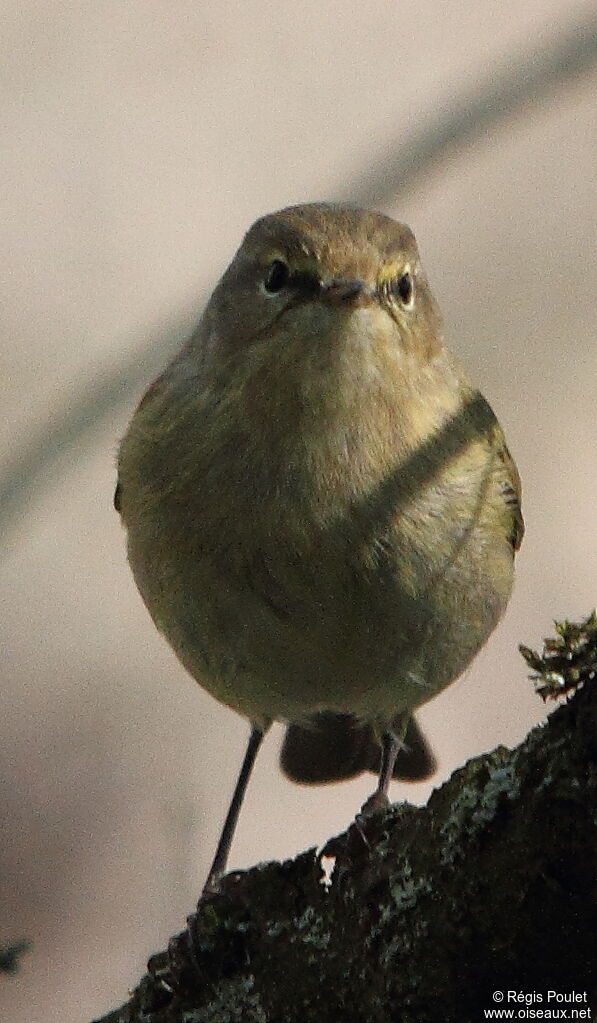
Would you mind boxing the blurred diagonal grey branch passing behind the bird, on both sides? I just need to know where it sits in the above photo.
[0,16,597,548]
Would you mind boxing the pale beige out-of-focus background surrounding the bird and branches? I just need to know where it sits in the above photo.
[0,0,597,1023]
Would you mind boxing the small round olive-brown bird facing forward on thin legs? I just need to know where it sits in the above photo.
[114,204,523,890]
